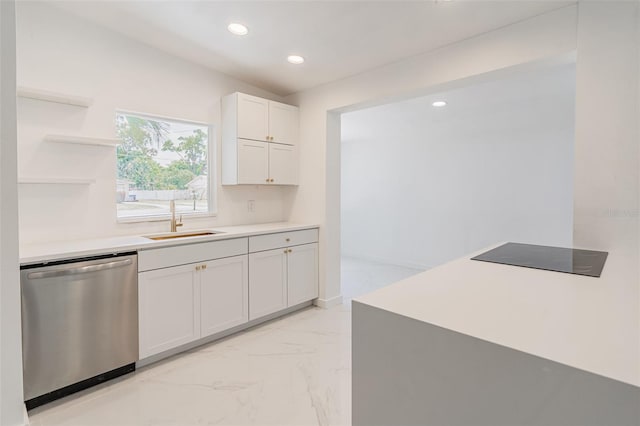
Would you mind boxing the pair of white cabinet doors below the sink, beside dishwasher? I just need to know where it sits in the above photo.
[138,255,249,359]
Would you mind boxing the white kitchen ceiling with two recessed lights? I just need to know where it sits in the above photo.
[48,0,575,96]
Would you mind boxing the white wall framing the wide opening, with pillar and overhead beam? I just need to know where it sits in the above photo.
[288,6,577,306]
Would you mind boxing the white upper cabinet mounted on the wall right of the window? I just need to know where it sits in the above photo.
[222,93,299,185]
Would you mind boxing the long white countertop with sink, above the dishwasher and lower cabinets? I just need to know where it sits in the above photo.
[20,222,318,265]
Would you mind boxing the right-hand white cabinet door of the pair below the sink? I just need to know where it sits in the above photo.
[200,255,249,337]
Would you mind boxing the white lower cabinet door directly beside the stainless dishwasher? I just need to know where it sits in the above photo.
[138,265,200,359]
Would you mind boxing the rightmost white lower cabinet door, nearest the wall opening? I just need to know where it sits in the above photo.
[287,243,318,306]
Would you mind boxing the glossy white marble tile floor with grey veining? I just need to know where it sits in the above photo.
[29,259,418,426]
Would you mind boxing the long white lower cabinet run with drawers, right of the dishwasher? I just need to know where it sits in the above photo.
[138,228,318,362]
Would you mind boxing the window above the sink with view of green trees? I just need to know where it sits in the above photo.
[116,113,213,221]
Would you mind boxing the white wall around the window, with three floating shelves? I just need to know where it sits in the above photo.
[17,2,293,243]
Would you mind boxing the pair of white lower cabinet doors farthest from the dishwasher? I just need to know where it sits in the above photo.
[249,243,318,320]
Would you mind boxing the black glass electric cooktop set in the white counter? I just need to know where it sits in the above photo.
[471,243,608,277]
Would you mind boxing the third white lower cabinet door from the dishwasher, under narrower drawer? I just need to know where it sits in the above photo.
[249,249,287,320]
